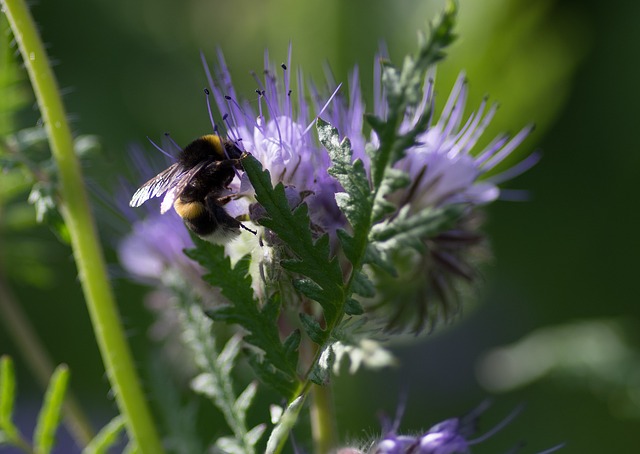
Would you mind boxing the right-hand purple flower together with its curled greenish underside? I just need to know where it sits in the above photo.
[318,58,539,332]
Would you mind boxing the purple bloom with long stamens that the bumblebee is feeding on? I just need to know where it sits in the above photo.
[205,48,345,238]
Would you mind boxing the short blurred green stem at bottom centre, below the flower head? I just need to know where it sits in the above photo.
[310,384,337,454]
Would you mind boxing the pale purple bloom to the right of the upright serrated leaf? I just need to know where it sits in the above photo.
[396,74,538,210]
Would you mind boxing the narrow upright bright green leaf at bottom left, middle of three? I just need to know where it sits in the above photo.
[33,364,69,454]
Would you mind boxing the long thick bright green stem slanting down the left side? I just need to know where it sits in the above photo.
[2,0,163,454]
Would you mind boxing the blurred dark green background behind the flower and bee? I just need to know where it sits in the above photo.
[0,0,640,453]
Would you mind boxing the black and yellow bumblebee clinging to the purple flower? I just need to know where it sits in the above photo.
[129,134,256,243]
